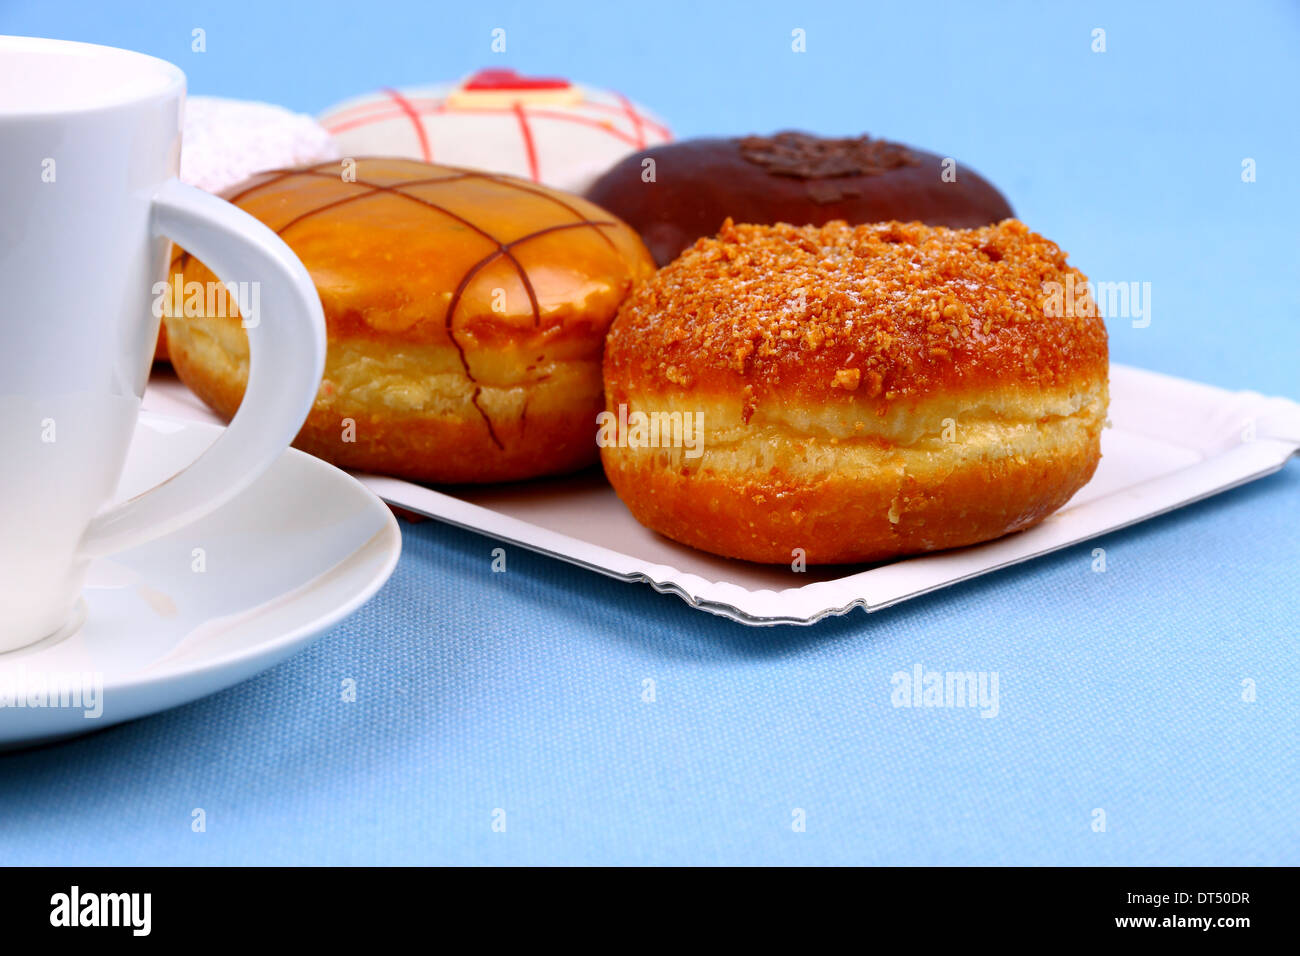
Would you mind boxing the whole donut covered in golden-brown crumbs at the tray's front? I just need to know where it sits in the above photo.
[598,220,1109,566]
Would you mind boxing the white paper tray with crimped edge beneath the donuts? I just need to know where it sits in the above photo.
[144,364,1300,624]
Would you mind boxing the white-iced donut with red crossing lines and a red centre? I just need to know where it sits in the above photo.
[320,69,676,195]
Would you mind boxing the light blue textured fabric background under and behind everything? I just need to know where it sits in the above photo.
[0,0,1300,864]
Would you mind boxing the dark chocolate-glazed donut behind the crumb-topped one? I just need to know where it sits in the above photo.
[585,131,1014,265]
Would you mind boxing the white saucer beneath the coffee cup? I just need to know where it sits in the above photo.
[0,412,402,748]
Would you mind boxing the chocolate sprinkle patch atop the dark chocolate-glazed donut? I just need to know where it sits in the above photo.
[737,131,920,179]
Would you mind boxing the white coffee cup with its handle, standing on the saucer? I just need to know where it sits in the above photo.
[0,36,325,653]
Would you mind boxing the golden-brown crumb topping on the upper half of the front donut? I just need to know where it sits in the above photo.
[607,220,1106,401]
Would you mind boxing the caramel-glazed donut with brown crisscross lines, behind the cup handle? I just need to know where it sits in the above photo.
[161,159,654,484]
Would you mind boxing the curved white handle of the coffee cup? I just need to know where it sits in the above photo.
[79,179,325,558]
